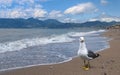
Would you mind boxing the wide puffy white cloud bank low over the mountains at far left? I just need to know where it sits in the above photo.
[0,8,47,18]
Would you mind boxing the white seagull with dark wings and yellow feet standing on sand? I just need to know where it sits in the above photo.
[78,37,100,70]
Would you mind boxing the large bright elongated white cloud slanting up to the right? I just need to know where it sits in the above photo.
[64,2,96,15]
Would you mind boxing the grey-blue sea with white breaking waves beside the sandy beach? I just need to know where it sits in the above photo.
[0,28,109,71]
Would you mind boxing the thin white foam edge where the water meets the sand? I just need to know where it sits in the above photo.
[0,29,109,72]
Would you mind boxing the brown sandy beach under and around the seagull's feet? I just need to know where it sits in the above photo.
[0,29,120,75]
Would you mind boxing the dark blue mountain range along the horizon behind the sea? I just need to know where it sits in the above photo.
[0,18,120,28]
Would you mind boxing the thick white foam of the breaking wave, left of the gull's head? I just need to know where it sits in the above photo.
[0,35,73,53]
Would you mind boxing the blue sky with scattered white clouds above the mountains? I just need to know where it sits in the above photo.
[0,0,120,23]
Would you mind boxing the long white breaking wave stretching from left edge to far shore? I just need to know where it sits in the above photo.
[0,30,105,53]
